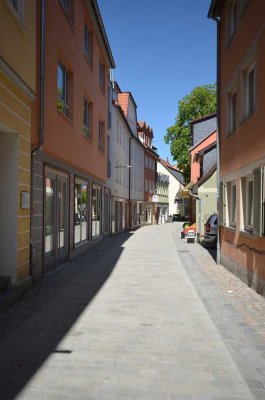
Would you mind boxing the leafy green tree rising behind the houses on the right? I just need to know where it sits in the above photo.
[164,84,216,183]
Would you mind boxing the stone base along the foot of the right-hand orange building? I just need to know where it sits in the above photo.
[220,252,265,297]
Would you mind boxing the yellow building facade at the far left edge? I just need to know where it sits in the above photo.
[0,0,36,288]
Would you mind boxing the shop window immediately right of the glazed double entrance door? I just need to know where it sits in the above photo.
[74,178,88,244]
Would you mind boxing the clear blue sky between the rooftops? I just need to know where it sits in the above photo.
[98,0,216,162]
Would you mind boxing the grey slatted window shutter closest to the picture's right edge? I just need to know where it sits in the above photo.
[253,167,264,236]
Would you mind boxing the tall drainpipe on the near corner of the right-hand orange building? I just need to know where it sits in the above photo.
[208,13,222,264]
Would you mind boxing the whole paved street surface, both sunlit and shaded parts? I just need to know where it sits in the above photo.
[0,223,265,400]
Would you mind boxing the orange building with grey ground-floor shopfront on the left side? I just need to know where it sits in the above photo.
[31,0,115,279]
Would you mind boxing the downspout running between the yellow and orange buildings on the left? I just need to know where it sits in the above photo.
[30,0,46,275]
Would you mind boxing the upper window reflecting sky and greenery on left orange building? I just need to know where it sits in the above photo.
[57,62,70,117]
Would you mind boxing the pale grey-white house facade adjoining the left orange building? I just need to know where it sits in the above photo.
[108,83,144,234]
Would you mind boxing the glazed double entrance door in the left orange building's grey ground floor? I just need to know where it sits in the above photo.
[43,171,68,273]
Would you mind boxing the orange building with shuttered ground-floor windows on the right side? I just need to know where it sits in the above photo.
[208,0,265,295]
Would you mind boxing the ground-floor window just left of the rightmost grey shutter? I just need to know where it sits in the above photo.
[241,175,254,232]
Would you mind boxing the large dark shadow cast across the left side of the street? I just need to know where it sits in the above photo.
[0,232,133,400]
